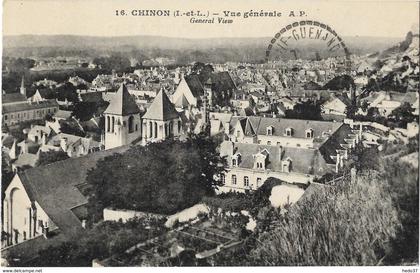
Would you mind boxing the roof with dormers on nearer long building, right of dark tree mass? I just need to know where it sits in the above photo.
[221,142,330,175]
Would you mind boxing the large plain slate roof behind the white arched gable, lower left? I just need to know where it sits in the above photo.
[18,146,129,235]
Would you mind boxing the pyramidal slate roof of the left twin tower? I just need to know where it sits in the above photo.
[104,84,140,116]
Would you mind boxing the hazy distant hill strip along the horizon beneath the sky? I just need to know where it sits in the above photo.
[3,35,400,59]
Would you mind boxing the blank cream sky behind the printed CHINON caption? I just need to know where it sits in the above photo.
[3,0,419,38]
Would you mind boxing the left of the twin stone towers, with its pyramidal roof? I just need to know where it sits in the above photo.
[104,84,141,150]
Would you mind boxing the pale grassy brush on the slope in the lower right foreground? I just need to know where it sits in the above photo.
[251,172,400,265]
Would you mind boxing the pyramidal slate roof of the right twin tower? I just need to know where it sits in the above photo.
[143,90,179,120]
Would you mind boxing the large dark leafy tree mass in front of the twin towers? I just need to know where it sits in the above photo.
[87,135,224,220]
